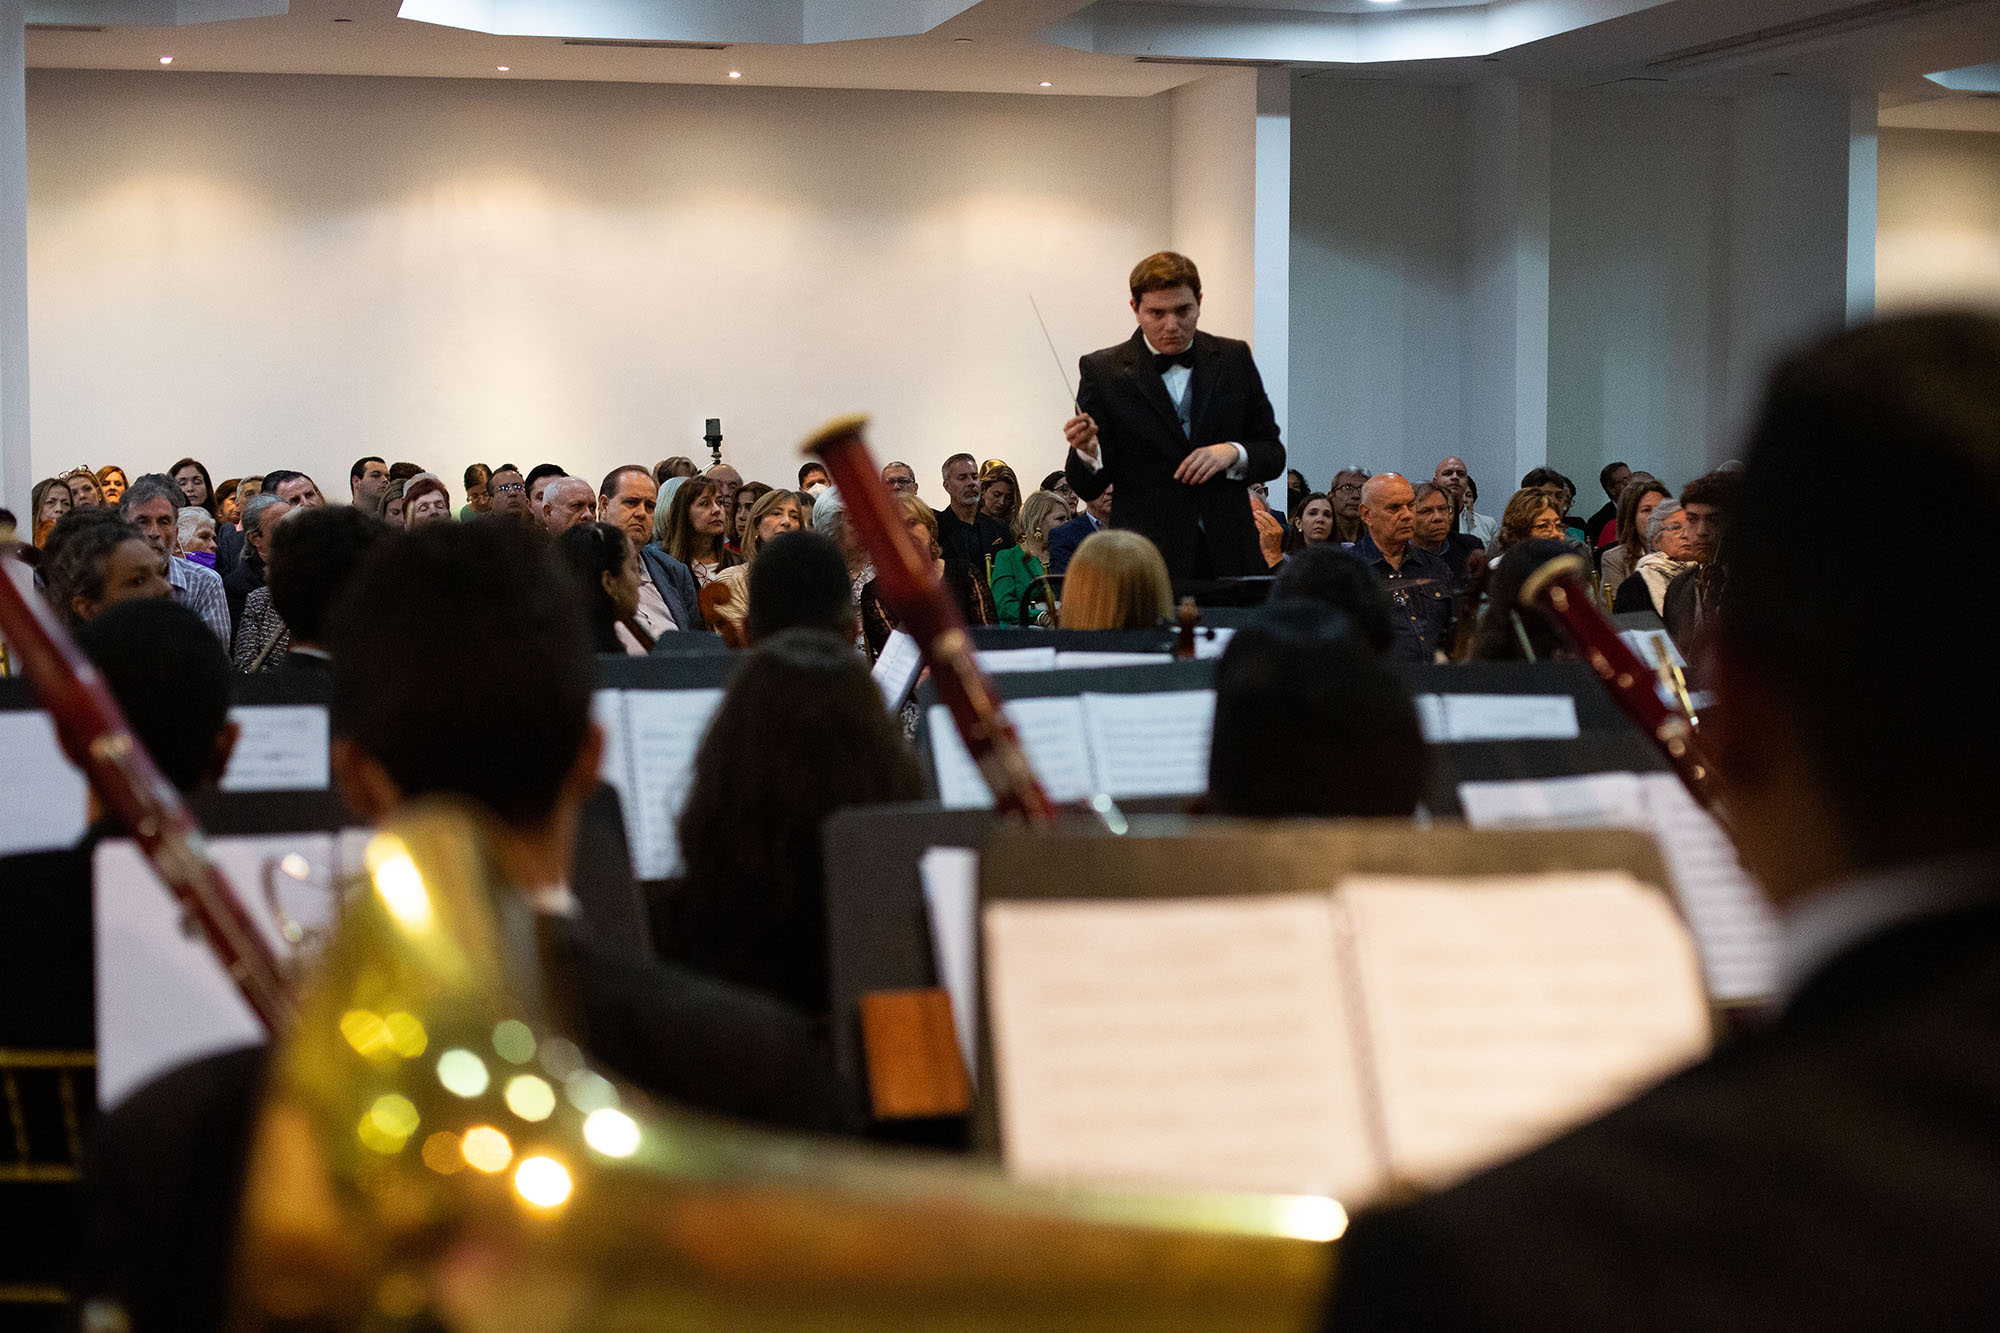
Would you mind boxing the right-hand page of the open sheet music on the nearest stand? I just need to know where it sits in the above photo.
[1334,873,1708,1185]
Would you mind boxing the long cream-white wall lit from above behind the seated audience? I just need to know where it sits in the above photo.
[27,70,1168,506]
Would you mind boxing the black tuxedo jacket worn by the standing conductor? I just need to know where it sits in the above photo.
[1064,328,1284,578]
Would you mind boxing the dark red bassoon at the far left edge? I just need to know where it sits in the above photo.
[0,556,292,1031]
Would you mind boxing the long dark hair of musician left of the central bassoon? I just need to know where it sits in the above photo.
[654,624,918,1013]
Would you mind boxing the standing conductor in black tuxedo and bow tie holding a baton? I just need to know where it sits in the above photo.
[1062,250,1284,578]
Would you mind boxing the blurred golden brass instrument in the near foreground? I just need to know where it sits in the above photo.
[234,803,1346,1333]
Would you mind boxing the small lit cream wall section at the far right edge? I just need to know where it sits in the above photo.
[1876,128,2000,312]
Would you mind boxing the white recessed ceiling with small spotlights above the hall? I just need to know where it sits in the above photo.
[28,0,2000,120]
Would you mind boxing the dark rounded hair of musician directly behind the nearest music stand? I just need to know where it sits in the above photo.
[1208,598,1430,819]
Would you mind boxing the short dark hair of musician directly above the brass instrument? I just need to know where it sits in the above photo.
[328,522,594,827]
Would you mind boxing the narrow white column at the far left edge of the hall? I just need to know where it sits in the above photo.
[0,0,34,512]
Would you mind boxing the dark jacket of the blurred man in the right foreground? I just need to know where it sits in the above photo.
[1326,891,2000,1333]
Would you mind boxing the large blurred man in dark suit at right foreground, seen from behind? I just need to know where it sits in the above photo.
[1328,314,2000,1333]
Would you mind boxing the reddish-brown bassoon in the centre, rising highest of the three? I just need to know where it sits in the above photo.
[804,416,1056,823]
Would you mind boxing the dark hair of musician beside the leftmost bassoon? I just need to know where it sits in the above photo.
[76,598,230,793]
